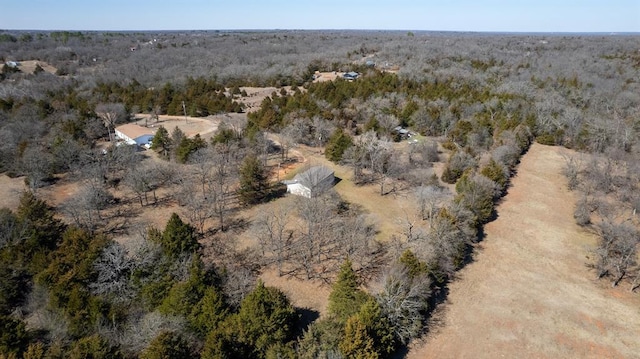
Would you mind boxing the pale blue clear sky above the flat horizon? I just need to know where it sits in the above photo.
[0,0,640,33]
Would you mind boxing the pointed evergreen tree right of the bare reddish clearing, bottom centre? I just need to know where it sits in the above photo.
[329,259,369,322]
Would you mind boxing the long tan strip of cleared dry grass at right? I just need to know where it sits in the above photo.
[408,144,640,359]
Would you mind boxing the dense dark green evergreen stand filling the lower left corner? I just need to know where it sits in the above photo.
[0,192,298,358]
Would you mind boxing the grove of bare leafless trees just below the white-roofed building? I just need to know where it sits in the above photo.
[251,192,384,281]
